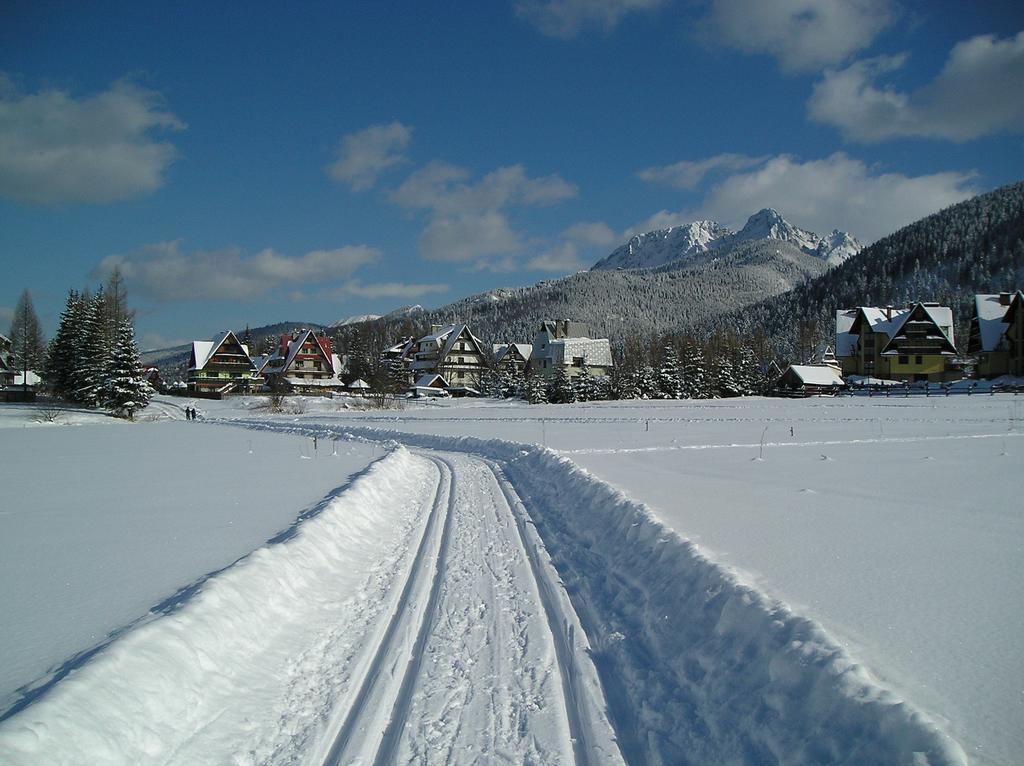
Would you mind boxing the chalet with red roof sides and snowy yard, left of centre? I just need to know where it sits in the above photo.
[262,330,344,393]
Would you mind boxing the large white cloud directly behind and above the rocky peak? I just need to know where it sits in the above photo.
[679,153,979,244]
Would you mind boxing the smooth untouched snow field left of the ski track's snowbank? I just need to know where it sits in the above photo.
[0,406,382,713]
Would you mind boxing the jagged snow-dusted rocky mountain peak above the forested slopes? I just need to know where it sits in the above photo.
[592,208,861,271]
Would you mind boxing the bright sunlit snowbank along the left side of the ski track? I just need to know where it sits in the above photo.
[0,450,437,766]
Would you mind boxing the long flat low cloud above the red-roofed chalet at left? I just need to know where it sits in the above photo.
[95,242,380,300]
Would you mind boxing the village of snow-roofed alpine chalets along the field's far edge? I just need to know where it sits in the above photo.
[142,291,1024,400]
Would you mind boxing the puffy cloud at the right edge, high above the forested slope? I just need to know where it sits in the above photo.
[808,32,1024,143]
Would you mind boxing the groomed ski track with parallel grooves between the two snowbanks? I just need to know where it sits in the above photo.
[315,454,620,764]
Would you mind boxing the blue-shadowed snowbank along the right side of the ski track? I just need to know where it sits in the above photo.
[226,422,967,766]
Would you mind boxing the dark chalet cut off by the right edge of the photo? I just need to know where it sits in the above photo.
[967,290,1024,378]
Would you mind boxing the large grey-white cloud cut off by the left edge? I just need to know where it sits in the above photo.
[0,75,185,205]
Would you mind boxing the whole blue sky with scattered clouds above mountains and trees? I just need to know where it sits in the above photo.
[0,0,1024,347]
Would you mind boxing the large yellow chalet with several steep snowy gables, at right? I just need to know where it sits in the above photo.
[836,302,961,382]
